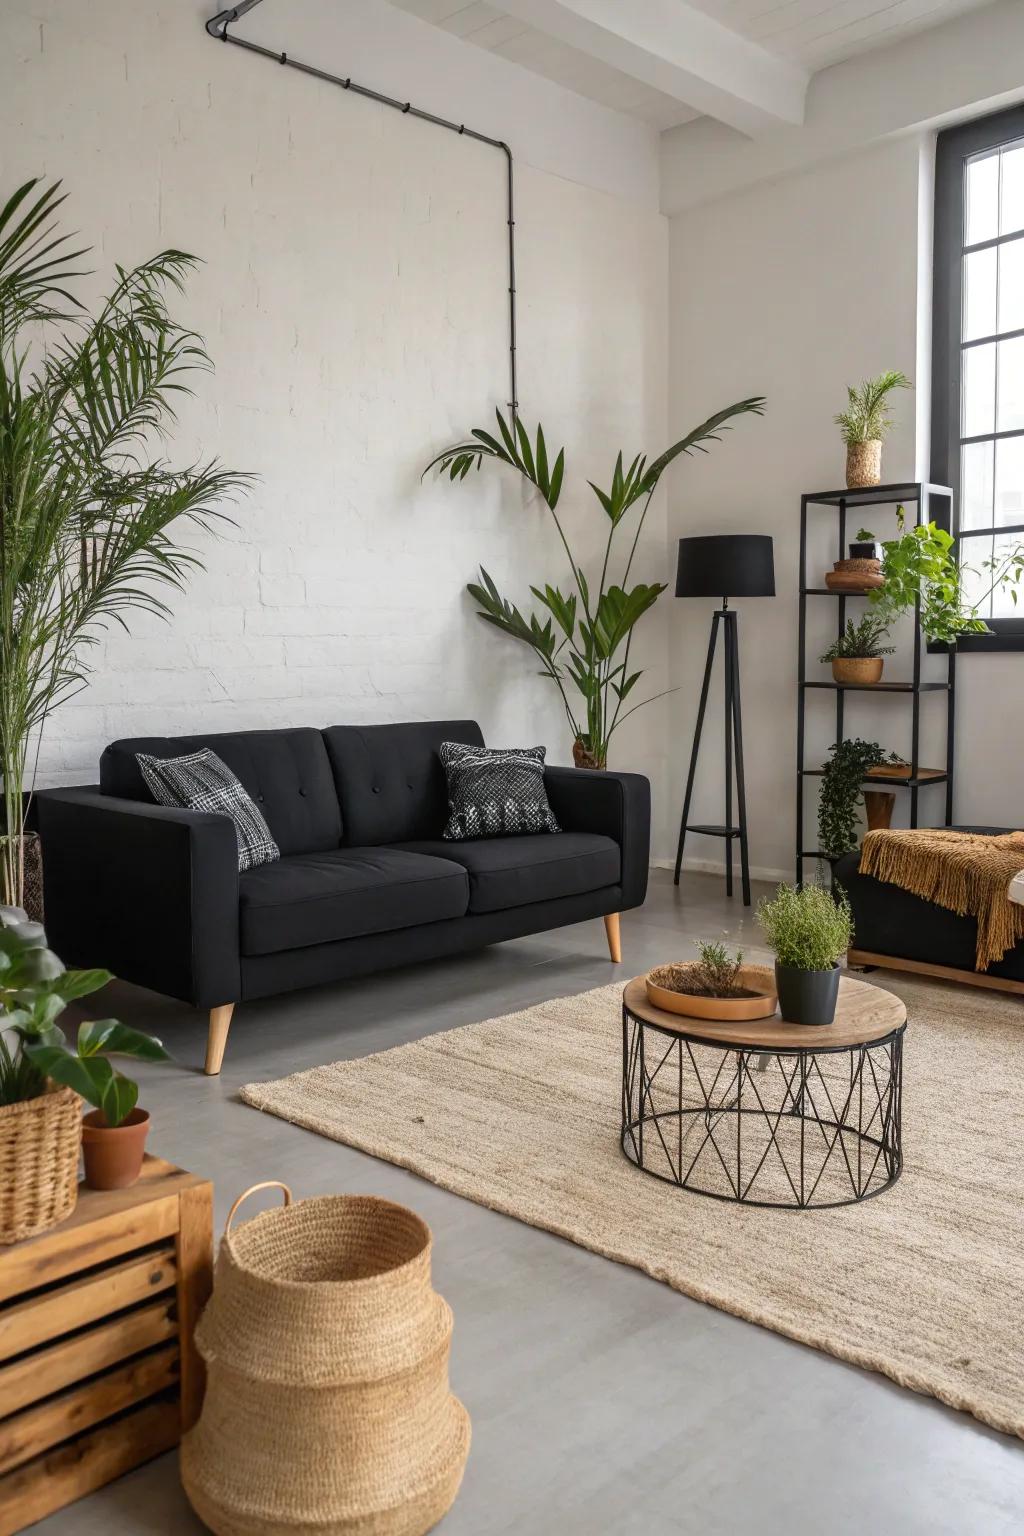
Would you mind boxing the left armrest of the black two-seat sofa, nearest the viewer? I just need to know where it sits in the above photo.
[37,788,241,1008]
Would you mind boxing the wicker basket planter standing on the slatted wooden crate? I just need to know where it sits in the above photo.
[0,1083,81,1243]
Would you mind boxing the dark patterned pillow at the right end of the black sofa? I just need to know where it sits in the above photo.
[439,742,562,842]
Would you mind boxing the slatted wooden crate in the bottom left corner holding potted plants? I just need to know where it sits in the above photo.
[0,1157,213,1536]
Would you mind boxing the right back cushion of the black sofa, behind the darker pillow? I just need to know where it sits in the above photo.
[324,720,484,848]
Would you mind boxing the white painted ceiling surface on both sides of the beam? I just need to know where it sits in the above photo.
[390,0,994,129]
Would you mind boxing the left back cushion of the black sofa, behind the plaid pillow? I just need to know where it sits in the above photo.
[100,730,341,854]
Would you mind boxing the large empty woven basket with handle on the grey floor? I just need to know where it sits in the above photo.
[181,1184,470,1536]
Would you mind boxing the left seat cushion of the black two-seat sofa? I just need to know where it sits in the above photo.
[238,848,468,955]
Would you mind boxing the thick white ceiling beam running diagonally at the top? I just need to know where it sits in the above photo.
[500,0,809,137]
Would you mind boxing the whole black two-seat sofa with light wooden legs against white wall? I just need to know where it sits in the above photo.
[37,720,649,1074]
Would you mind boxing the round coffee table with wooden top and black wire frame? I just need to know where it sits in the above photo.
[620,975,907,1210]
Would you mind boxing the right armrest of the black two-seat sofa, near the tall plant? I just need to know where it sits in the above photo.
[543,768,651,911]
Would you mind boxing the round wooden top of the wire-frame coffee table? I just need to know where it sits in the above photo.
[622,975,907,1051]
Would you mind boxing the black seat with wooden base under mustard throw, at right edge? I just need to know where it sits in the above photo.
[834,826,1024,991]
